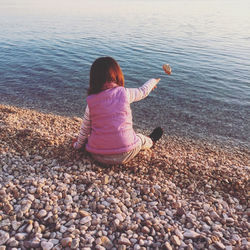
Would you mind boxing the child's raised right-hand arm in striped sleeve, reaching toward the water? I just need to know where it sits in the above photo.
[126,78,161,103]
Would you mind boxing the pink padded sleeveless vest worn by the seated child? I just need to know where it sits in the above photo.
[86,86,140,154]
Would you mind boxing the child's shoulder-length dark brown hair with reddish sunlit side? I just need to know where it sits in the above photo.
[88,57,124,95]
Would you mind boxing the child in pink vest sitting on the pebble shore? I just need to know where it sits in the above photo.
[73,57,170,164]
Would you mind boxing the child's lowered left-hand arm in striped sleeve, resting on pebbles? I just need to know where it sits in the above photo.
[73,105,91,149]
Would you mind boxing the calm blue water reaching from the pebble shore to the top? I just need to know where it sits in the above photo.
[0,0,250,146]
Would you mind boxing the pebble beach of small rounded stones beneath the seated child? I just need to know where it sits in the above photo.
[0,105,250,250]
